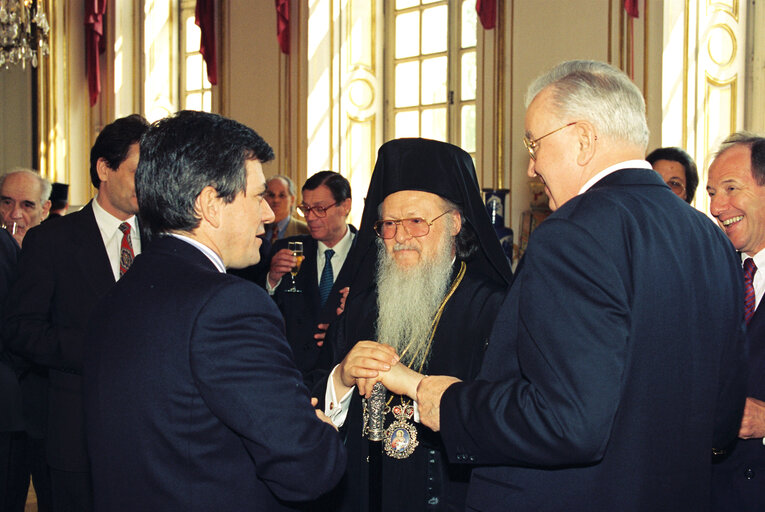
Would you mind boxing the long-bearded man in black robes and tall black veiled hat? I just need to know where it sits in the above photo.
[325,139,511,511]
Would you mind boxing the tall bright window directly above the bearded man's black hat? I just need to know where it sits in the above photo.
[385,0,477,153]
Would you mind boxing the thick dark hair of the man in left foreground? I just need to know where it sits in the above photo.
[135,110,274,235]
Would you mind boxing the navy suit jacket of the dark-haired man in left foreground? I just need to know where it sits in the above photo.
[84,237,345,511]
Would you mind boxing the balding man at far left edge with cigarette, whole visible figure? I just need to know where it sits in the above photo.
[0,169,52,512]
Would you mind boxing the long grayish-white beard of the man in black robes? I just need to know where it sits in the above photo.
[375,229,454,370]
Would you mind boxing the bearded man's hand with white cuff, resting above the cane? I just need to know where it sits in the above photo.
[332,341,398,396]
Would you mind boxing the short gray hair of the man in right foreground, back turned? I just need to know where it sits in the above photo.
[526,60,648,151]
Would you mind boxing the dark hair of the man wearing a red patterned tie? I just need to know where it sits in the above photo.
[90,114,149,188]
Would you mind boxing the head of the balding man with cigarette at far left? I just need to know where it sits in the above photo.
[0,169,51,247]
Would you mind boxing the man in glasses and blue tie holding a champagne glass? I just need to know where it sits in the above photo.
[266,171,356,387]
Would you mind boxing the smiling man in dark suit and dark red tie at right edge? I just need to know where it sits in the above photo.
[707,132,765,512]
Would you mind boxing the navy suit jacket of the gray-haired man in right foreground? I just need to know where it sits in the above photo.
[441,169,746,512]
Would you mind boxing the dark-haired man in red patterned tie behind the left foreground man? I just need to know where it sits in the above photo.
[3,115,148,512]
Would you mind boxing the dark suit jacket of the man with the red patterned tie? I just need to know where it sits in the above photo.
[3,204,145,471]
